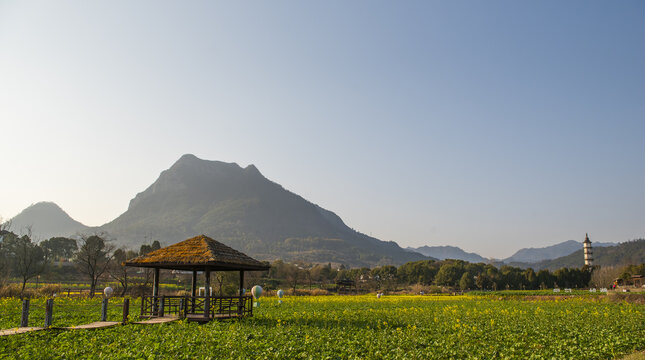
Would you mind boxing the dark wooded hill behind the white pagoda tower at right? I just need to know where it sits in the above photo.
[515,239,645,271]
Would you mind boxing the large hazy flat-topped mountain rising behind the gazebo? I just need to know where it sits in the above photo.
[100,155,426,266]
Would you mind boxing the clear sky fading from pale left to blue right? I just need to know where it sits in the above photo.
[0,1,645,258]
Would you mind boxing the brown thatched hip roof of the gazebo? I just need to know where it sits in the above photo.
[125,235,269,270]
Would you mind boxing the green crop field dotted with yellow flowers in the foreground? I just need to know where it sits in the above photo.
[0,296,645,359]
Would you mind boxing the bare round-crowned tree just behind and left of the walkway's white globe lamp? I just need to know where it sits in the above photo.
[74,234,113,297]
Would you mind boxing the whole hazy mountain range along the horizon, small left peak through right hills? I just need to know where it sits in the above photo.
[5,155,638,268]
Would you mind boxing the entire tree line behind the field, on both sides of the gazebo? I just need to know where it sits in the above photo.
[0,229,645,296]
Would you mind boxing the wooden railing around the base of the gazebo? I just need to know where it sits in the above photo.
[141,296,253,318]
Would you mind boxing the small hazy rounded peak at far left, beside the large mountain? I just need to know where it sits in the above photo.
[4,202,90,239]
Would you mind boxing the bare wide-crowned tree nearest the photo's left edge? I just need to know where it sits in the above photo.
[3,231,47,296]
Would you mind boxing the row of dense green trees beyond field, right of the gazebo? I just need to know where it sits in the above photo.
[267,259,593,291]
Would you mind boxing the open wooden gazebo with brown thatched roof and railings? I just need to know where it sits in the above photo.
[124,235,270,322]
